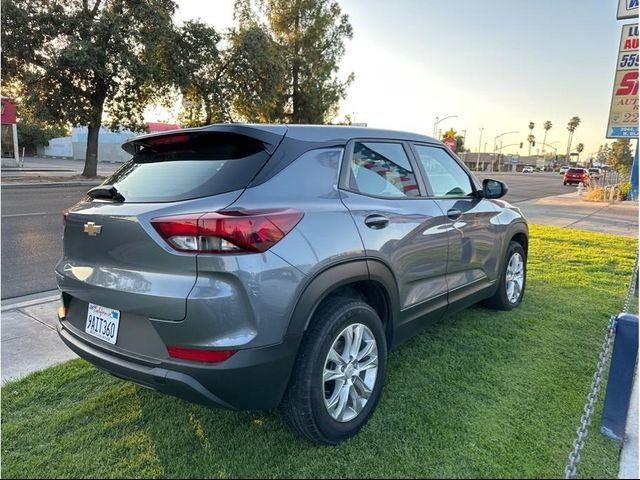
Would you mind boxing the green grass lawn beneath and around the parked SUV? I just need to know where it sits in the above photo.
[2,226,637,478]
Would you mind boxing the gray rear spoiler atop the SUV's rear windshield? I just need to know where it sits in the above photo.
[122,123,287,155]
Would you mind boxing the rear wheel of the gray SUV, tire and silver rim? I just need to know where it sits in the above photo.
[280,296,387,445]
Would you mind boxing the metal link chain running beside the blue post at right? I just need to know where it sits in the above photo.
[564,252,638,478]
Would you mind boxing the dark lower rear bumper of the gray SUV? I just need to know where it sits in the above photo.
[58,319,300,410]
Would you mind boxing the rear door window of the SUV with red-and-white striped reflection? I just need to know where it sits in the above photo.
[349,142,419,197]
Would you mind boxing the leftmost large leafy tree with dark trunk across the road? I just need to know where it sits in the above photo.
[2,0,175,177]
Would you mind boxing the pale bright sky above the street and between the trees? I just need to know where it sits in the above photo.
[164,0,631,155]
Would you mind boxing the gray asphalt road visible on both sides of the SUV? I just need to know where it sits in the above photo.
[1,173,575,299]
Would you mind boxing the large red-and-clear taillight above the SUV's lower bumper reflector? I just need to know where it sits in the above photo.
[151,209,304,253]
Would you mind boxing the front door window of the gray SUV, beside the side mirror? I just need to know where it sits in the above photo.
[415,145,473,197]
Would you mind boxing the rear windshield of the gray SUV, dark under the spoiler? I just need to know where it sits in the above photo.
[105,133,269,202]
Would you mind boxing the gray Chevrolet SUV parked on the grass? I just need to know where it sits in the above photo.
[56,124,528,444]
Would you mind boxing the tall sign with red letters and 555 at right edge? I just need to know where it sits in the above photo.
[607,23,640,138]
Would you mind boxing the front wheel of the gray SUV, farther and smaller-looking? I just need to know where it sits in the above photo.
[483,241,527,310]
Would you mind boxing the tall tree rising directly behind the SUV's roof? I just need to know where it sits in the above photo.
[236,0,353,123]
